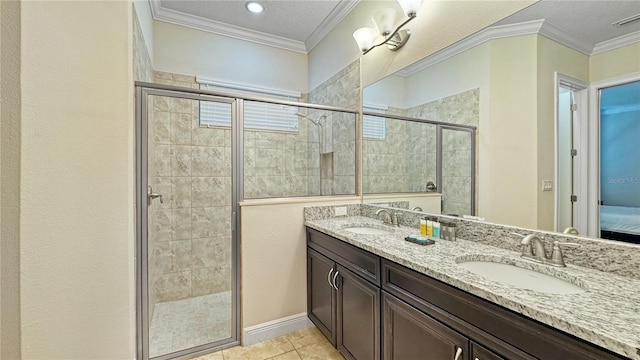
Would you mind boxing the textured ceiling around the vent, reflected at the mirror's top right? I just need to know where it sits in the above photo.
[496,0,640,46]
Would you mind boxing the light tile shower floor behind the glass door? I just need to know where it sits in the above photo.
[149,291,231,357]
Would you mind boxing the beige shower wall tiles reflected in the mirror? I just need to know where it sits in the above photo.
[362,89,479,214]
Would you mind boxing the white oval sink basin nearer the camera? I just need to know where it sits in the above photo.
[458,261,585,294]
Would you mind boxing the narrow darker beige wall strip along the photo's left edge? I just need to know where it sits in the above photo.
[0,1,21,359]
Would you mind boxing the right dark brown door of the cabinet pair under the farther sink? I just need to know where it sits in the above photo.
[336,265,380,360]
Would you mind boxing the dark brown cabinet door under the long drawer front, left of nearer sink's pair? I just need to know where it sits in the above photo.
[382,292,469,360]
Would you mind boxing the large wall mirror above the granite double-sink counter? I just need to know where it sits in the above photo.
[362,0,640,242]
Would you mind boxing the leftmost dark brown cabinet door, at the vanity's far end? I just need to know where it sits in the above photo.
[307,249,336,346]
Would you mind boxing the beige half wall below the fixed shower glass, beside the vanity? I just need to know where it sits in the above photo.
[240,197,360,328]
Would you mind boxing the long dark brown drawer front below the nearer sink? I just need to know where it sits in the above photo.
[382,260,623,360]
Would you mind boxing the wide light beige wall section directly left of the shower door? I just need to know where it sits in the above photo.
[21,1,135,359]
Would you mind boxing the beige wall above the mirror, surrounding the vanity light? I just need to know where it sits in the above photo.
[309,1,535,88]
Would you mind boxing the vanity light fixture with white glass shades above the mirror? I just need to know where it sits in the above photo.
[353,0,422,55]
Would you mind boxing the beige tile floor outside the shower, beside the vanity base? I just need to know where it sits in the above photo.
[192,327,344,360]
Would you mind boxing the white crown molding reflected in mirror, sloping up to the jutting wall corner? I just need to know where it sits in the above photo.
[397,20,544,77]
